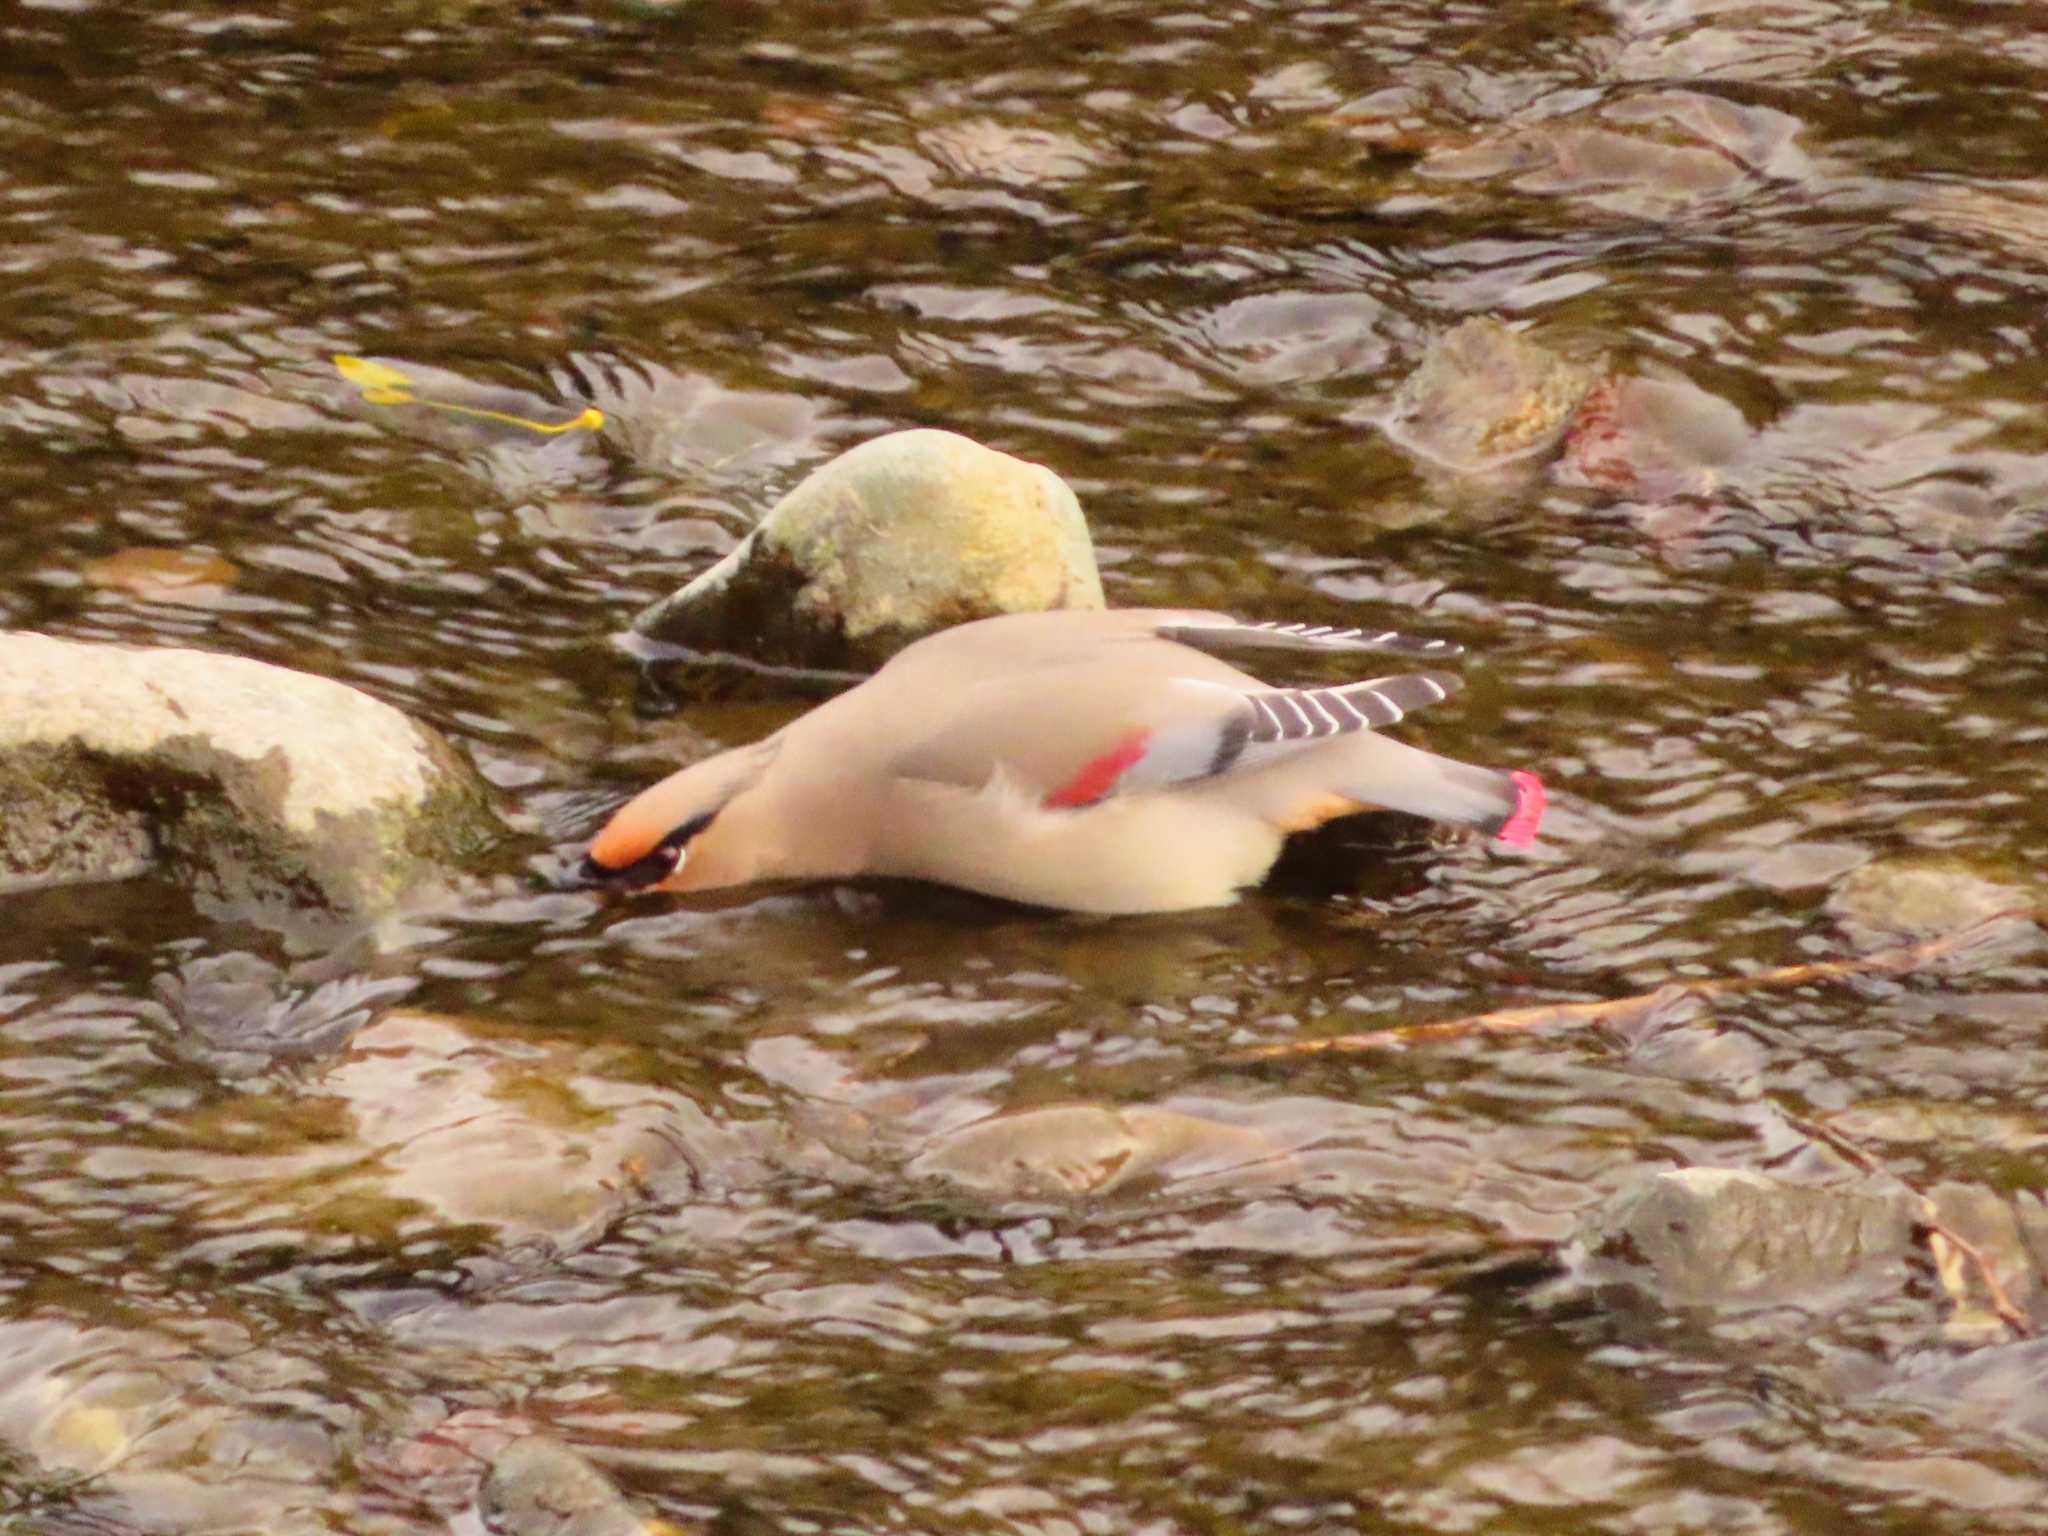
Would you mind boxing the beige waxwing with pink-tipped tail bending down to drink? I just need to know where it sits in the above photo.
[582,608,1544,911]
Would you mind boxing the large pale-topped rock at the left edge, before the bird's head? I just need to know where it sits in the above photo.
[0,631,504,918]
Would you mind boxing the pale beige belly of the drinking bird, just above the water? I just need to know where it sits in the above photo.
[877,784,1282,913]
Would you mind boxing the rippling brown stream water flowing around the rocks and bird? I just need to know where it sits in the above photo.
[0,0,2048,1536]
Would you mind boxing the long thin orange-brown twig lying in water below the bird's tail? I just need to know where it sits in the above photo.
[1225,907,2044,1063]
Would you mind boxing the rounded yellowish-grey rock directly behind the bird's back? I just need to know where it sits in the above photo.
[633,430,1102,666]
